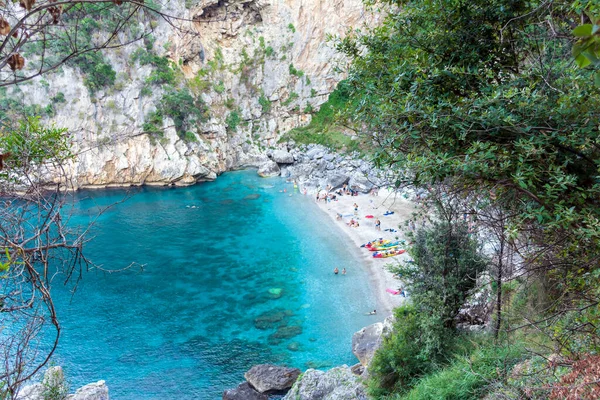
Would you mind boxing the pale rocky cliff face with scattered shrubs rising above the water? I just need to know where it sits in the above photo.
[12,0,373,186]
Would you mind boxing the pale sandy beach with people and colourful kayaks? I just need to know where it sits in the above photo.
[312,189,414,317]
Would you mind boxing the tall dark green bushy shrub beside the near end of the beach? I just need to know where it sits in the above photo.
[370,219,487,395]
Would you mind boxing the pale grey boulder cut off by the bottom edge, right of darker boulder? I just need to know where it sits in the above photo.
[283,365,367,400]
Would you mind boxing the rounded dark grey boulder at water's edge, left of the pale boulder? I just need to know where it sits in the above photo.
[244,364,300,393]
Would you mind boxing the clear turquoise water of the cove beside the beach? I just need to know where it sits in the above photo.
[53,171,376,400]
